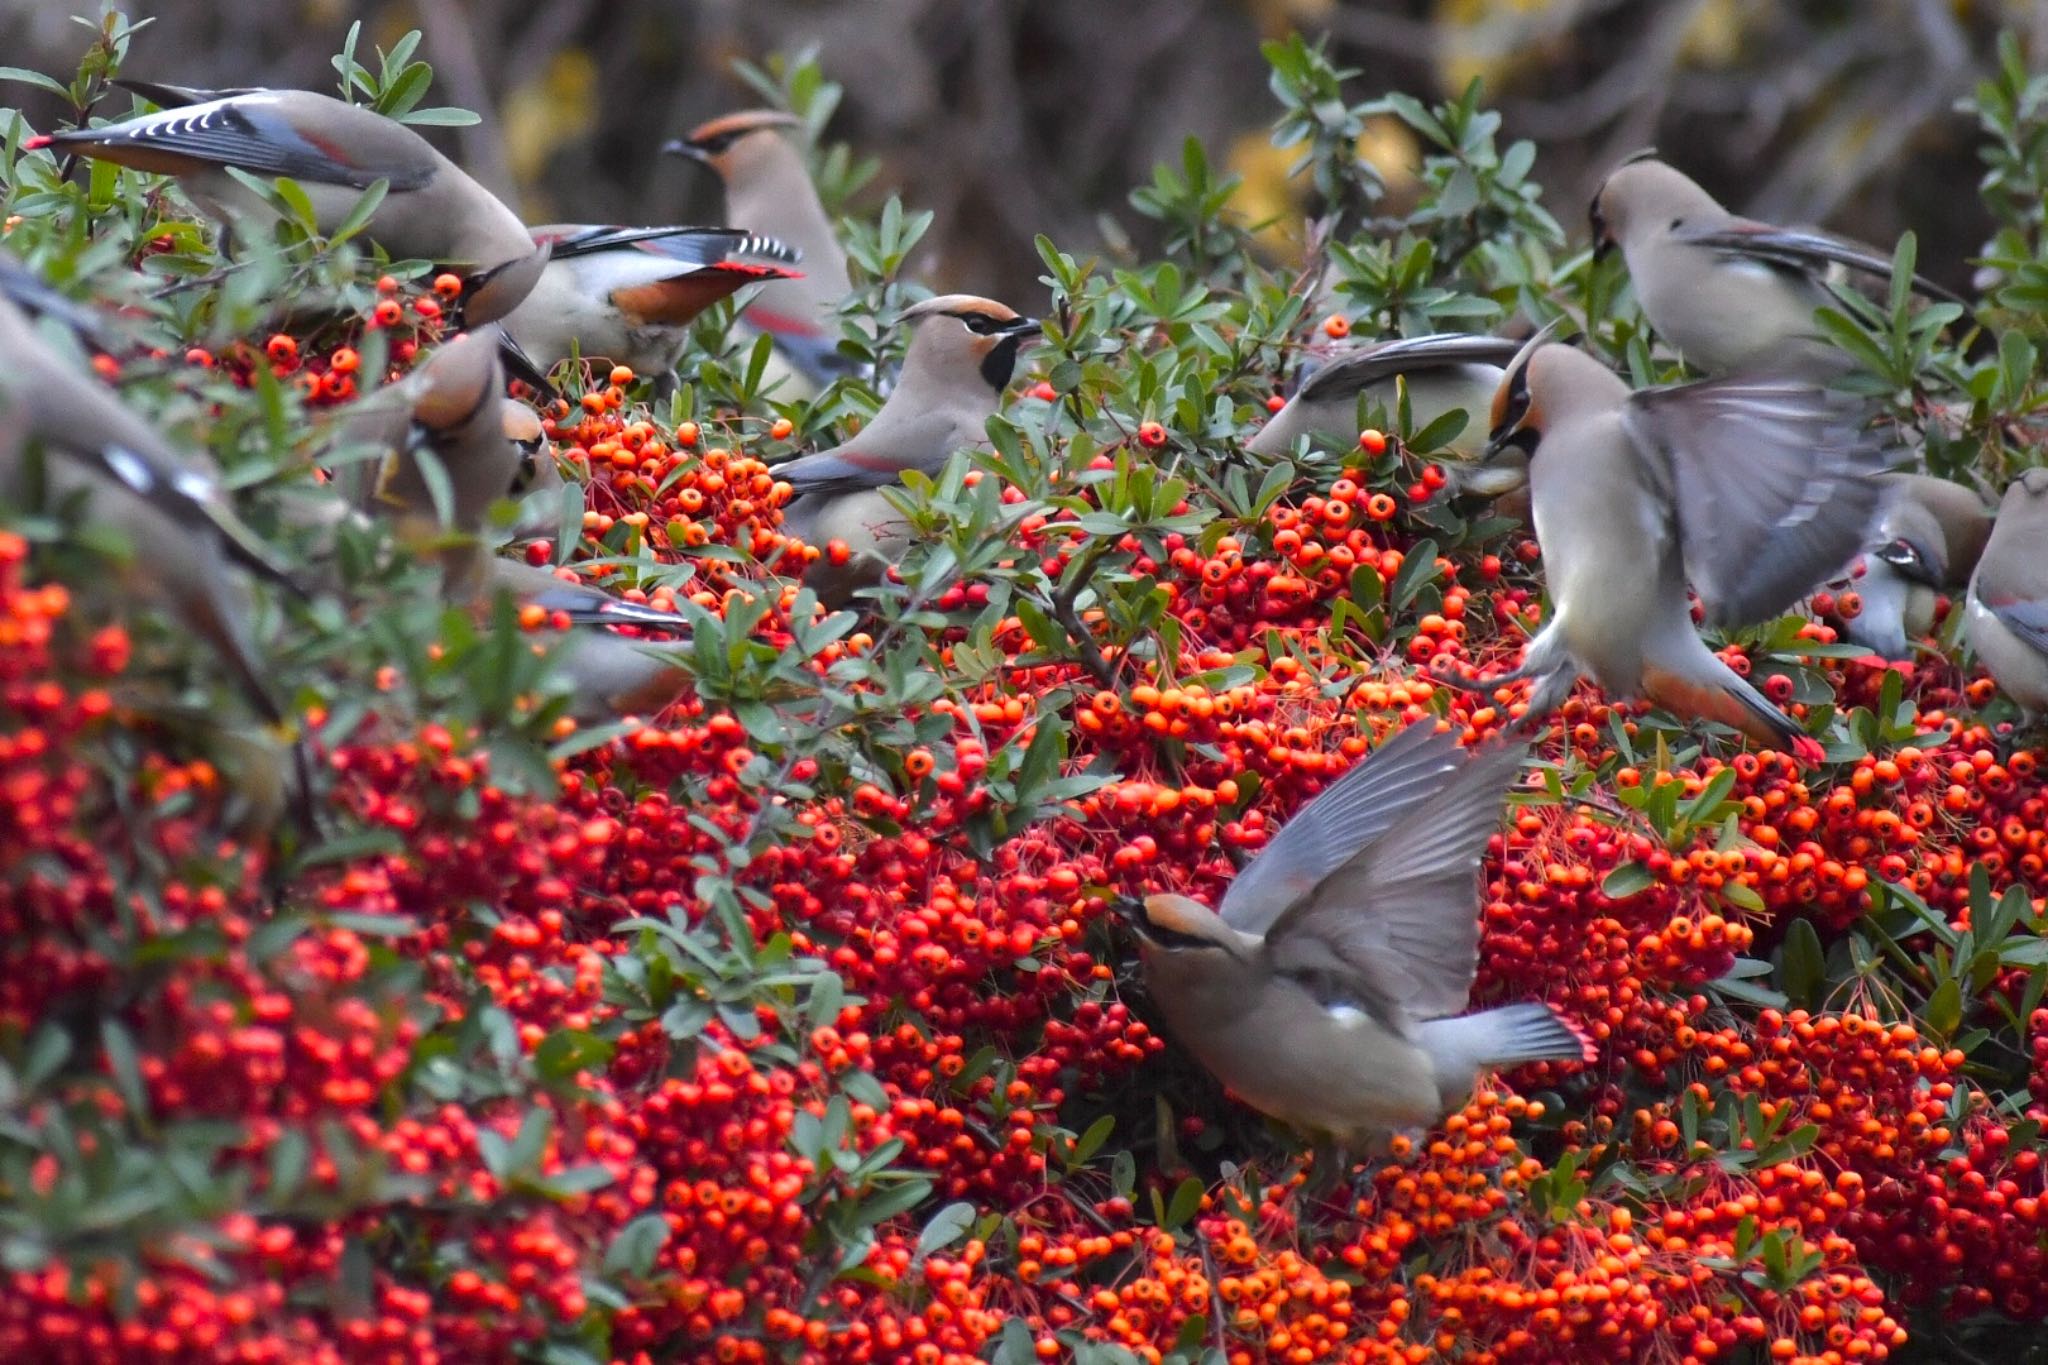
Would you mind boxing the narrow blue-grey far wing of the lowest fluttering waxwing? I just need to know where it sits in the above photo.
[1217,722,1460,933]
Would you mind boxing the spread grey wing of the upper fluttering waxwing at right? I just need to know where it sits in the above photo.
[1622,377,1890,624]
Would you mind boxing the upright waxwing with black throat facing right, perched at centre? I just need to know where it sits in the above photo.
[772,295,1038,606]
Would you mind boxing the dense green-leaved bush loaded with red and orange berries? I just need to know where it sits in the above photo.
[0,20,2048,1365]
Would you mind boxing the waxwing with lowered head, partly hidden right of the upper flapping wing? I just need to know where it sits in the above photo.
[1843,473,1991,659]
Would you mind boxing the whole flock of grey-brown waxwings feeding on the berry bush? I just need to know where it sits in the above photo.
[0,82,2048,1146]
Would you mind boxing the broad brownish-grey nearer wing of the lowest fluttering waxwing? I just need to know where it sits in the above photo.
[1266,741,1528,1019]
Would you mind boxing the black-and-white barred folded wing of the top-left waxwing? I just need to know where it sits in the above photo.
[49,92,434,190]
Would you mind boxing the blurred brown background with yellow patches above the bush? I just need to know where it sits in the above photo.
[0,0,2048,301]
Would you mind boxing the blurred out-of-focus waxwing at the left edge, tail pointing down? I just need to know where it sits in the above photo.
[0,291,301,722]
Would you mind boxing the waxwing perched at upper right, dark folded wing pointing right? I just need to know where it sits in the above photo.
[1589,158,1960,375]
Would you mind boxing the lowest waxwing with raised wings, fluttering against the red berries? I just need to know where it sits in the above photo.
[1133,722,1593,1148]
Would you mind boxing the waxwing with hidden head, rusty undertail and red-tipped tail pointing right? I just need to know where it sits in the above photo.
[504,225,801,375]
